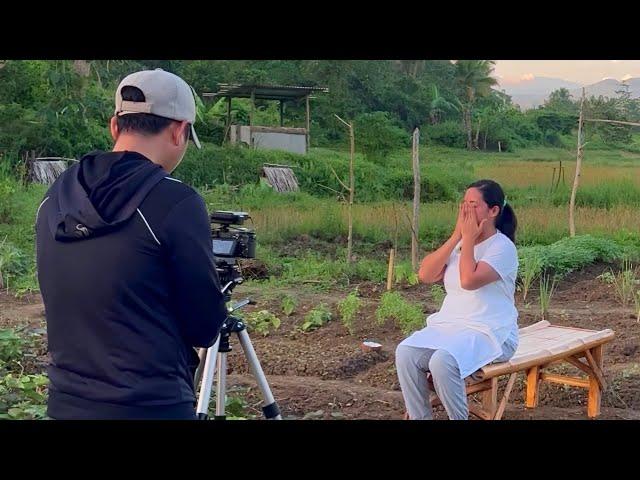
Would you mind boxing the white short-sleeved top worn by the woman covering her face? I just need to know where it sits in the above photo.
[401,231,518,378]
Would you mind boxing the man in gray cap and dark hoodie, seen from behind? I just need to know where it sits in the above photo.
[36,69,227,419]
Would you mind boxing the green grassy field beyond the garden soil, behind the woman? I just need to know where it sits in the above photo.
[0,145,640,292]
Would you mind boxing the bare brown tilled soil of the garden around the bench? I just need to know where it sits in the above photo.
[0,265,640,420]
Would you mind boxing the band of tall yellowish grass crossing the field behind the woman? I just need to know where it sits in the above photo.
[205,193,640,250]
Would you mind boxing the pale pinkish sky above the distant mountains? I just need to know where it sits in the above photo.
[494,60,640,86]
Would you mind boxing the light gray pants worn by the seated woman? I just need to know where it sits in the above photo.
[396,342,517,420]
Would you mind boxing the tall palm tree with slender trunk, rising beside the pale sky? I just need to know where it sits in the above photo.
[456,60,498,150]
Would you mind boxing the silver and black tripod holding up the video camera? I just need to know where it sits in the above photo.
[194,277,282,420]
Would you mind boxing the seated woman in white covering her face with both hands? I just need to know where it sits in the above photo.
[396,180,518,420]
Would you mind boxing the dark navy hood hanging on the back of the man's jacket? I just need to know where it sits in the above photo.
[48,152,167,242]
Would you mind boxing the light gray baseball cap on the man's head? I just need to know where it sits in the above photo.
[115,68,201,148]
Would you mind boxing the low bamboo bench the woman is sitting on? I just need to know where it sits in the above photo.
[420,321,615,420]
